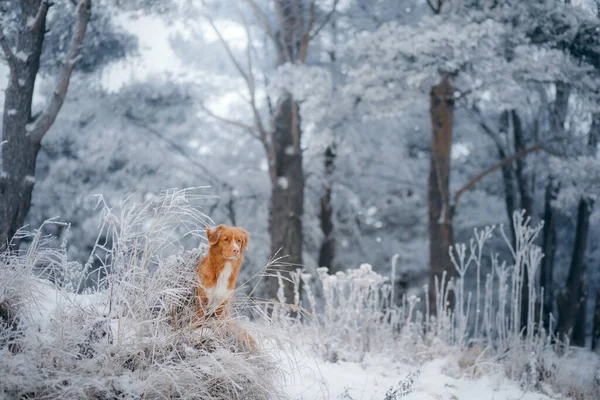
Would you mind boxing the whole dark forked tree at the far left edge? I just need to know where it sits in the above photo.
[0,0,92,249]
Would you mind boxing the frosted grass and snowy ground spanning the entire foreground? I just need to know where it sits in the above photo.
[0,191,600,400]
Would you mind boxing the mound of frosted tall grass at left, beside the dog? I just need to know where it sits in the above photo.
[0,191,280,399]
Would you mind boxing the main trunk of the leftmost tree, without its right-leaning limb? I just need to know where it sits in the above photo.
[0,0,46,250]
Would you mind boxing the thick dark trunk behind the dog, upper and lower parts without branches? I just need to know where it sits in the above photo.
[263,0,311,302]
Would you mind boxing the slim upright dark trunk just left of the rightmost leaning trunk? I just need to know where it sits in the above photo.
[540,177,557,332]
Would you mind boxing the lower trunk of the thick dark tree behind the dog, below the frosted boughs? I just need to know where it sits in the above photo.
[266,95,304,302]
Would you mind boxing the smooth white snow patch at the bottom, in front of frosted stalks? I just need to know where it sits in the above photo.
[284,351,550,400]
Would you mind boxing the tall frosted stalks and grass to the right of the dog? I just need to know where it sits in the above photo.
[275,213,600,399]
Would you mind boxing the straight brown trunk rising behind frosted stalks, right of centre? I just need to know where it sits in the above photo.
[427,77,456,312]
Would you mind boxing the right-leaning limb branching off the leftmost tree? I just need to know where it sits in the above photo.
[28,0,92,142]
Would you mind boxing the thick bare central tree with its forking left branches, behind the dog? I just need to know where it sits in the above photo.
[204,0,338,300]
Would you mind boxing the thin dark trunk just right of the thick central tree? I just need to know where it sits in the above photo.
[319,143,336,273]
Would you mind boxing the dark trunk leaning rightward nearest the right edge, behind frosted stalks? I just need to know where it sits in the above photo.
[557,199,592,346]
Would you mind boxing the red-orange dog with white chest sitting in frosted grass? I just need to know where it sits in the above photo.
[196,225,249,318]
